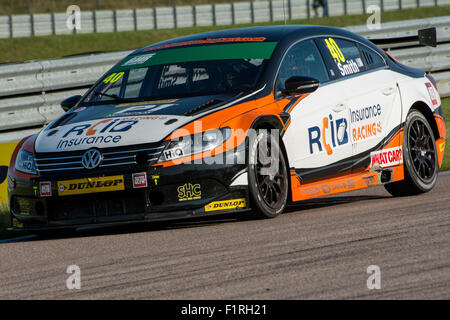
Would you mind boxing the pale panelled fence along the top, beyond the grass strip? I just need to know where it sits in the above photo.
[0,0,450,38]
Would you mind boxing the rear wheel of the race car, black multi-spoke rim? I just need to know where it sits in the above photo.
[385,110,439,196]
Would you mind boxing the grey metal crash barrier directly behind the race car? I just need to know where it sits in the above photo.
[0,16,450,142]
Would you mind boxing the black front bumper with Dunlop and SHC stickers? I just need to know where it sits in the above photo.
[8,151,250,231]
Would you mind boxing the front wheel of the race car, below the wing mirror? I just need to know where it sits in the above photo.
[248,130,289,218]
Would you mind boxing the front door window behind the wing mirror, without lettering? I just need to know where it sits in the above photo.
[276,40,329,91]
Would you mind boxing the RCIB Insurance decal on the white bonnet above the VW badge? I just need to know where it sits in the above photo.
[56,119,139,149]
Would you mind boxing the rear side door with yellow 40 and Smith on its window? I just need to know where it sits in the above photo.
[322,37,401,172]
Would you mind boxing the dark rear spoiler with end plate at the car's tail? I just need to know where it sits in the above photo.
[369,27,437,49]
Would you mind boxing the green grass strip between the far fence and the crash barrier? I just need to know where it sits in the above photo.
[0,6,450,63]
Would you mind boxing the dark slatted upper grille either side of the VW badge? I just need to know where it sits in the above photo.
[36,144,165,175]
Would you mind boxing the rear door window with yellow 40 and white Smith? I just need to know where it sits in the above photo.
[321,37,366,77]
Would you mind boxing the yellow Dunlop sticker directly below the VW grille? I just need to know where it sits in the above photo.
[58,176,125,196]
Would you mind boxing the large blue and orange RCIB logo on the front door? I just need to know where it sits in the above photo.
[308,114,348,155]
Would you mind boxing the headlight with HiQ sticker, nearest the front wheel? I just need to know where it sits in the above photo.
[158,127,231,162]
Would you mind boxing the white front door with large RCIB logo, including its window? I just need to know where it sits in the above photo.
[275,40,352,183]
